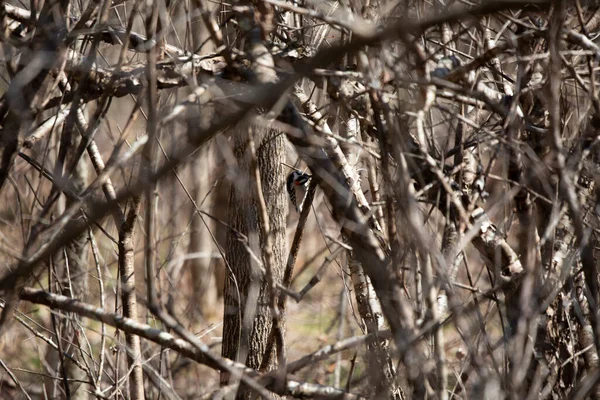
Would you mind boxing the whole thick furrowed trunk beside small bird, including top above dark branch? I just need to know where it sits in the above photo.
[221,2,288,398]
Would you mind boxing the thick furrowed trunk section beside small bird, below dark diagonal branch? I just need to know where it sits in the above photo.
[222,123,287,398]
